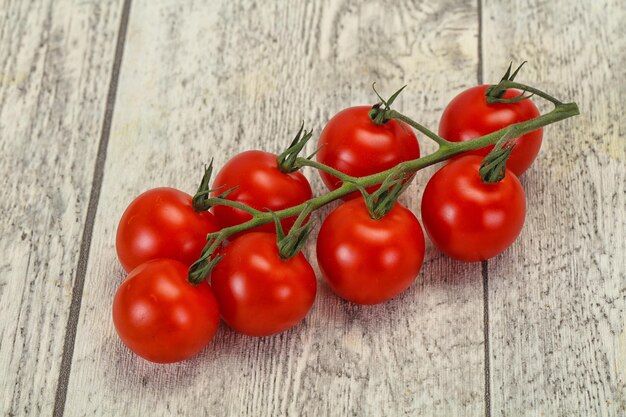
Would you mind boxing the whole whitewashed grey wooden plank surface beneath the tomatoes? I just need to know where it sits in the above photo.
[0,0,626,417]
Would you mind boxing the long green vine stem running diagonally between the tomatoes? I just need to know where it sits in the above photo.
[189,80,580,283]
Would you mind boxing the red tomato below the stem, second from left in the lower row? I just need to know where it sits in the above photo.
[211,232,317,336]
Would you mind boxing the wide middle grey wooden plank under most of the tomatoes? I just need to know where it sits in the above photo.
[65,0,484,416]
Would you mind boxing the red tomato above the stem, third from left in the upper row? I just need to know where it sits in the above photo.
[317,106,420,200]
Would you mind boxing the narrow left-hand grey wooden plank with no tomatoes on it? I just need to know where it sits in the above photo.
[0,0,125,416]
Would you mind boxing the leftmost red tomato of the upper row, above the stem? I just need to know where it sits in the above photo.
[115,188,219,272]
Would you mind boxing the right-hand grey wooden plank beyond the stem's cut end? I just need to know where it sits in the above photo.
[483,0,626,417]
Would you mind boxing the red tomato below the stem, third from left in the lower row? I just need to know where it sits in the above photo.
[317,198,424,304]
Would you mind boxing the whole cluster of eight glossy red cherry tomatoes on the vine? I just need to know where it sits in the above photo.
[113,81,542,362]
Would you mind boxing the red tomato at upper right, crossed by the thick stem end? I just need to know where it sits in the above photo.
[439,85,543,176]
